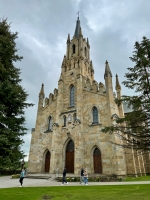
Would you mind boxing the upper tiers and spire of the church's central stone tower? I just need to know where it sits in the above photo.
[61,17,94,81]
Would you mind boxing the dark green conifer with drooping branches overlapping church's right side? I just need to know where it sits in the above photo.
[102,37,150,151]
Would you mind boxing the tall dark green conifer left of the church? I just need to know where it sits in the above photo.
[0,19,33,172]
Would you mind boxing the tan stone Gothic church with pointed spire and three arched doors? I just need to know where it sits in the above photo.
[28,17,150,176]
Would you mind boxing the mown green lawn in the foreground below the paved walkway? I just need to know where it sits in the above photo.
[0,185,150,200]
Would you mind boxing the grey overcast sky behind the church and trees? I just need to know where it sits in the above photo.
[0,0,150,160]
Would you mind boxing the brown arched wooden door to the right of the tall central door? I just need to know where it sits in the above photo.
[93,148,102,174]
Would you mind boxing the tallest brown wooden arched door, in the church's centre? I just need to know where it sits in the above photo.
[66,140,74,173]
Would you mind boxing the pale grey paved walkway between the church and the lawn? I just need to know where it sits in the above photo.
[0,176,150,188]
